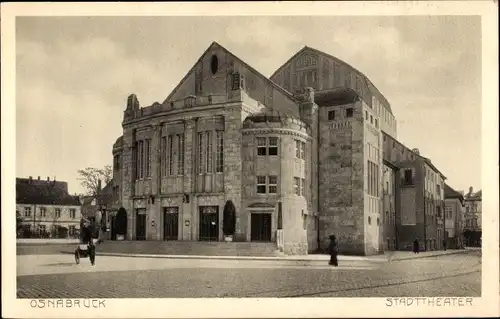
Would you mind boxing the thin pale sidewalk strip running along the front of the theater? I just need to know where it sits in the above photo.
[92,249,471,263]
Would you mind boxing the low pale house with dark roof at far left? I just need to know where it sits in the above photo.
[16,176,81,238]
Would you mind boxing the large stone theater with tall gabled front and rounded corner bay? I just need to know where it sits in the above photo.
[113,42,410,255]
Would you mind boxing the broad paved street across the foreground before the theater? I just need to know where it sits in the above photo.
[17,251,481,298]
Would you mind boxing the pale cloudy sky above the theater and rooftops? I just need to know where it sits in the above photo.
[16,16,481,193]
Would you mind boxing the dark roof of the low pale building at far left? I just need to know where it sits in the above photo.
[16,180,80,206]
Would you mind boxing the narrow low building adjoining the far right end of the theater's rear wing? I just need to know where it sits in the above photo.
[444,184,465,248]
